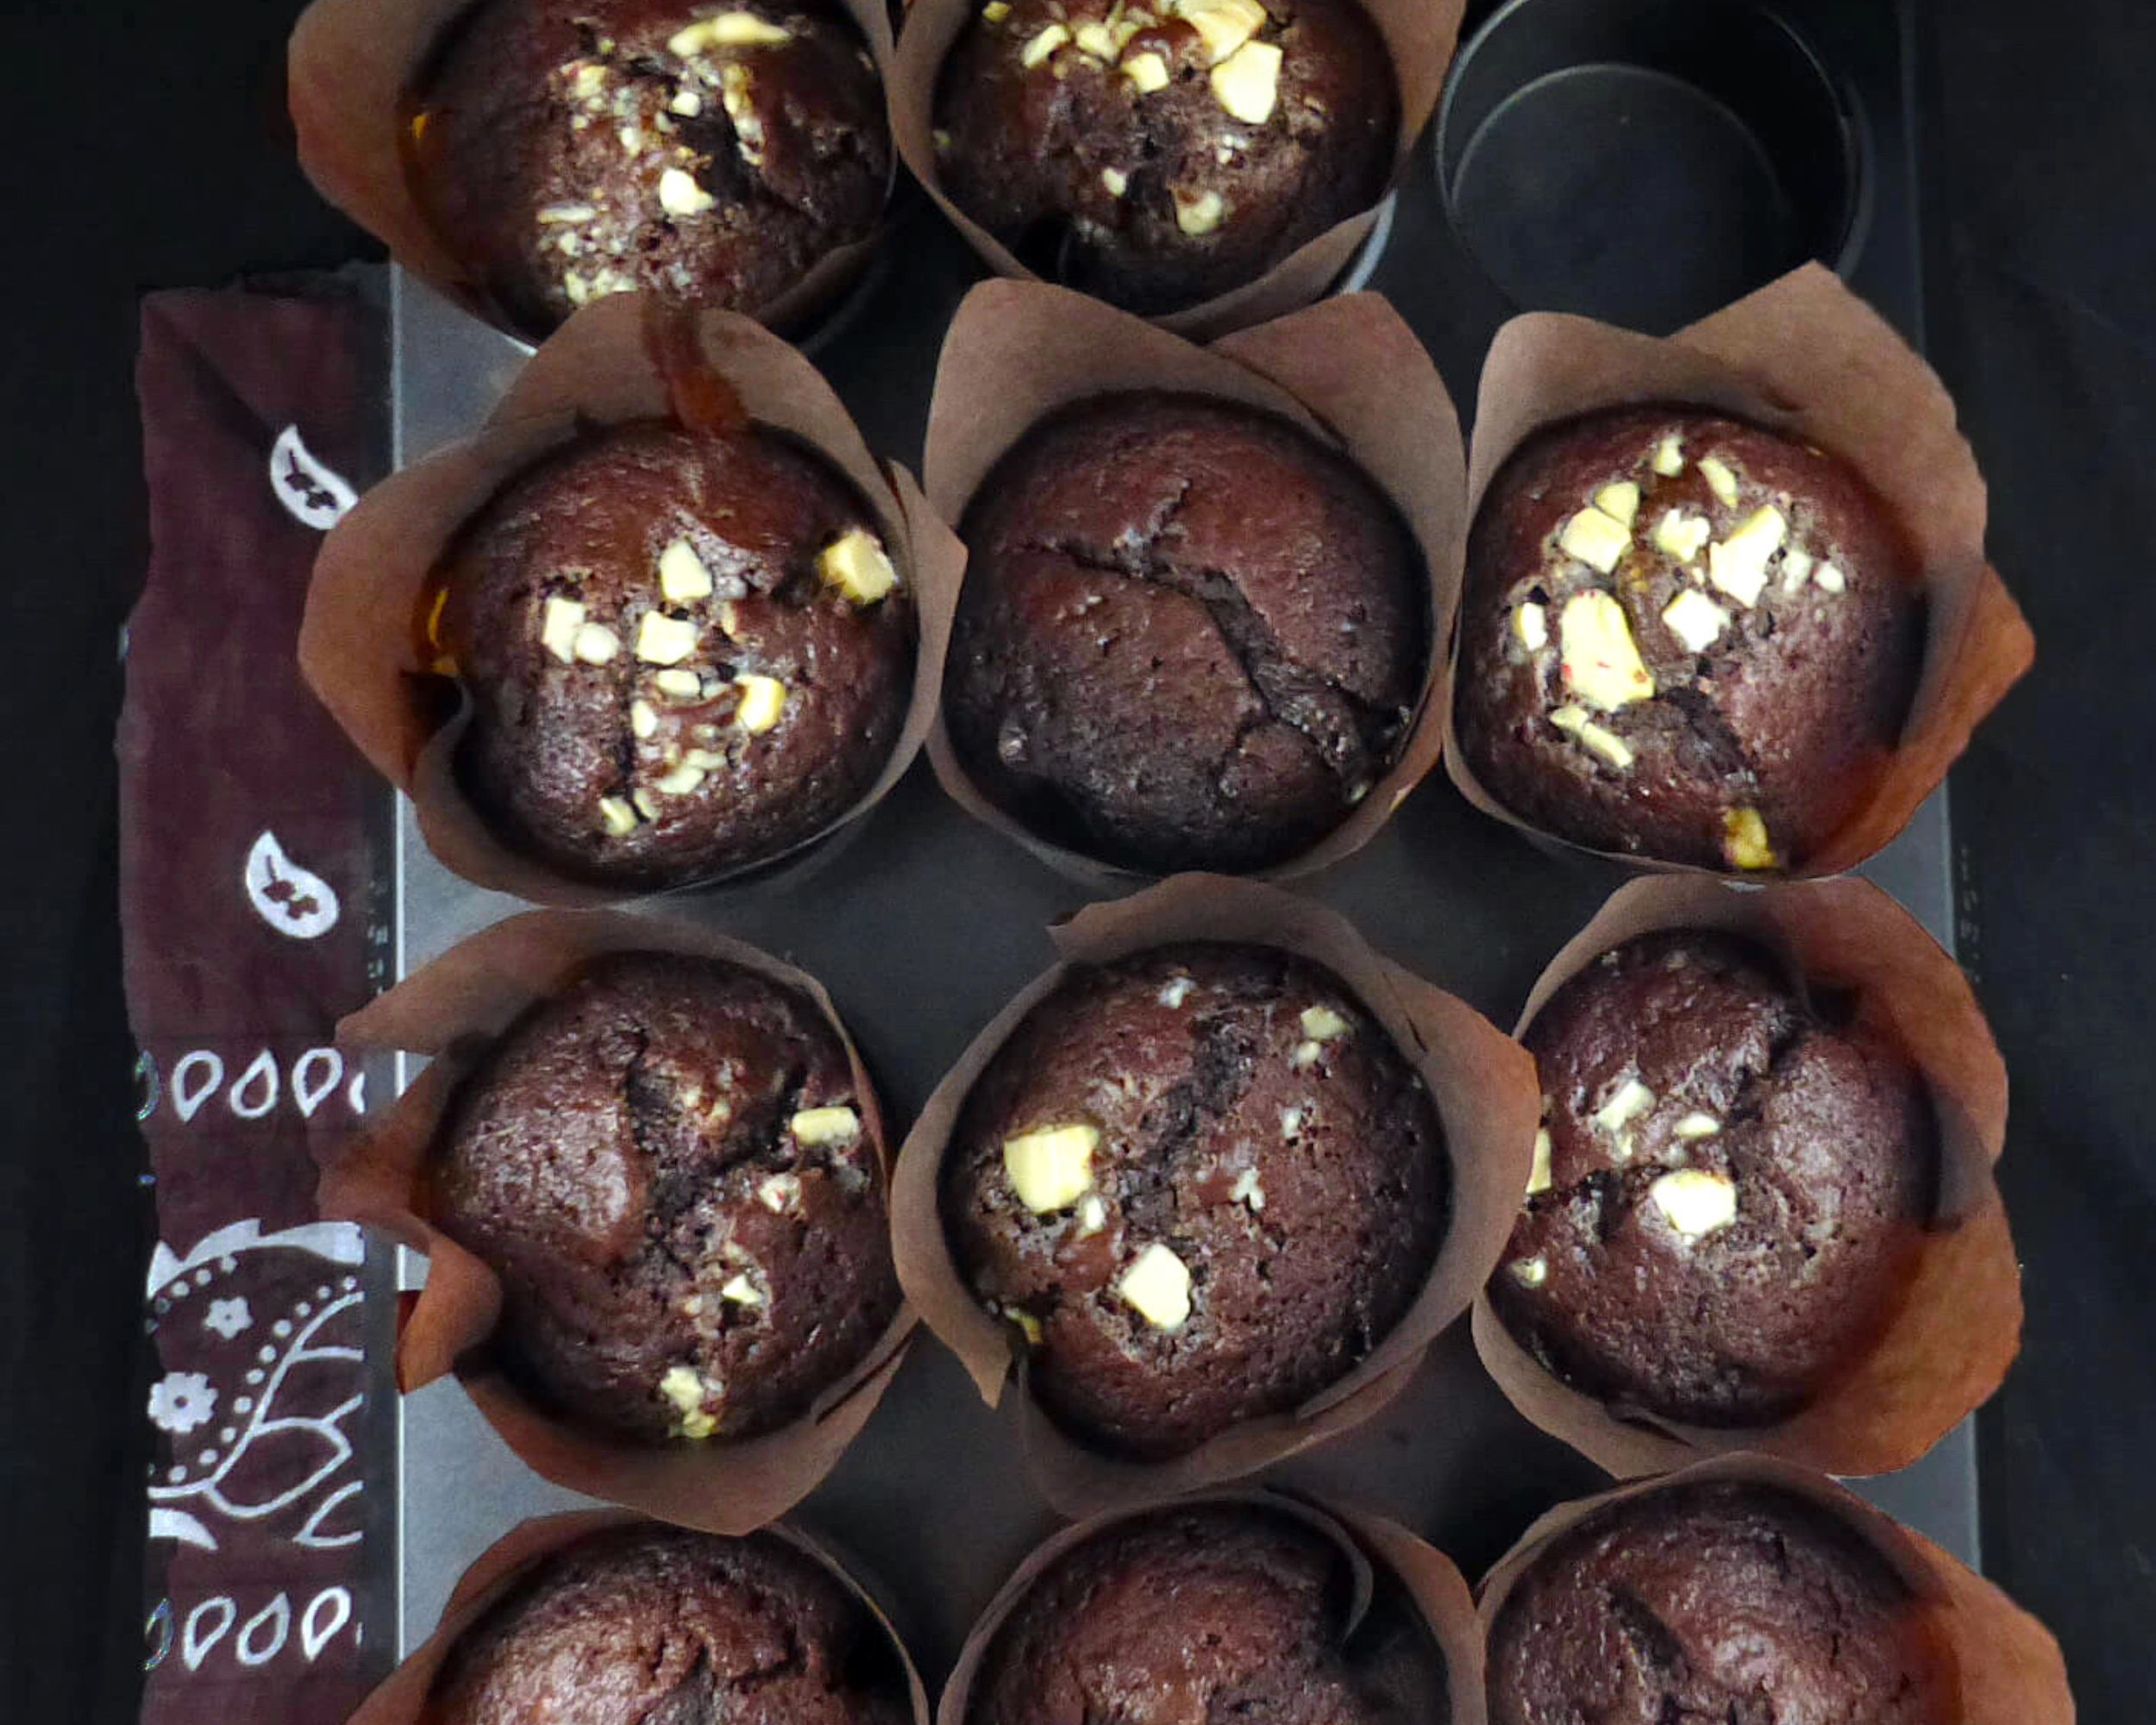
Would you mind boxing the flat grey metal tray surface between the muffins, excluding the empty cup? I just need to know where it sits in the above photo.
[378,0,1979,1682]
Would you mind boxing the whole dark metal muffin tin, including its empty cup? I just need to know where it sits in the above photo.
[371,0,1977,1682]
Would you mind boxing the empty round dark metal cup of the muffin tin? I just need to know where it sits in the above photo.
[1436,0,1870,335]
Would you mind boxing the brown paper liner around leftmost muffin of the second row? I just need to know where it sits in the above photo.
[300,286,966,906]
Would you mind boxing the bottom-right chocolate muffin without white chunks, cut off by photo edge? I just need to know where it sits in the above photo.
[1488,1482,1962,1725]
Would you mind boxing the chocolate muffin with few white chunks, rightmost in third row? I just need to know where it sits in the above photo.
[1490,934,1939,1426]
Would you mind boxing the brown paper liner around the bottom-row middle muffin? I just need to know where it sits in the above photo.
[940,1486,1486,1725]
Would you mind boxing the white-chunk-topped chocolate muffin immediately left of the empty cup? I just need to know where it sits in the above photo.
[936,0,1400,315]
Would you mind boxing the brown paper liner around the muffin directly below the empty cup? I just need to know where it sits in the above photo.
[1445,263,2035,878]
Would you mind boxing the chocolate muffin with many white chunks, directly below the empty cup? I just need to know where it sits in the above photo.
[1456,408,1923,871]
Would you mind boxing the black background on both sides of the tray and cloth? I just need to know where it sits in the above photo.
[0,0,2156,1723]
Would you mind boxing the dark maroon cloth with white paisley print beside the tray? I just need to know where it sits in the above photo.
[119,283,392,1725]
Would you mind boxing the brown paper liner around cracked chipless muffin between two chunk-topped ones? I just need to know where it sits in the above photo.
[923,283,1466,891]
